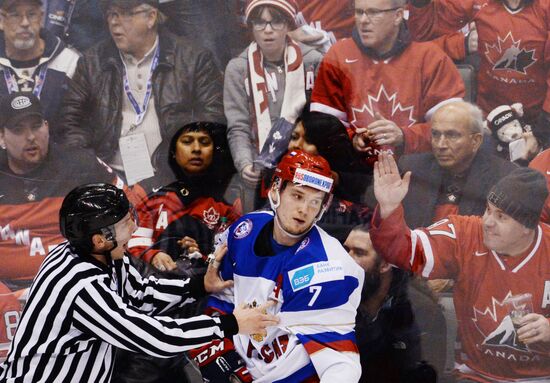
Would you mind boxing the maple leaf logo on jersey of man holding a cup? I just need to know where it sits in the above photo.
[472,291,530,352]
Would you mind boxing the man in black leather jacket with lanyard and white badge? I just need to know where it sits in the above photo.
[61,0,224,183]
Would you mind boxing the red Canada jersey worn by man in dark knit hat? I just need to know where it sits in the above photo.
[370,208,550,382]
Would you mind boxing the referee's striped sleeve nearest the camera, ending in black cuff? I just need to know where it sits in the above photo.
[73,280,238,358]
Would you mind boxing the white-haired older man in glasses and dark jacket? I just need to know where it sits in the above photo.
[399,101,516,228]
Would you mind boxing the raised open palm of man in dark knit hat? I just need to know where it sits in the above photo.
[374,152,411,219]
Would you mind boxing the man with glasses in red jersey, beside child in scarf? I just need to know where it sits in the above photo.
[311,0,464,160]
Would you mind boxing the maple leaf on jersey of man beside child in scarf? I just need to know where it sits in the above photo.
[351,85,416,129]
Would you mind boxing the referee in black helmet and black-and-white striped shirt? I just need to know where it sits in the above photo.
[0,184,277,382]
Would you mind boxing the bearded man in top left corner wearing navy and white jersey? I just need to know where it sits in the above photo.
[0,0,79,135]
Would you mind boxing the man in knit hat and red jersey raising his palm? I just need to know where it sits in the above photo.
[370,154,550,382]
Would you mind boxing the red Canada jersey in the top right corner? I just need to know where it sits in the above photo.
[409,0,550,121]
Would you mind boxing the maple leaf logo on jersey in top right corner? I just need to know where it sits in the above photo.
[485,32,537,74]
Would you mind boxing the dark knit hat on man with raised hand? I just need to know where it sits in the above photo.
[487,167,548,229]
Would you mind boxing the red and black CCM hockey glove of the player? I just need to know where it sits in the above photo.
[188,339,252,383]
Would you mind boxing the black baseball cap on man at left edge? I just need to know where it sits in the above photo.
[0,92,44,129]
